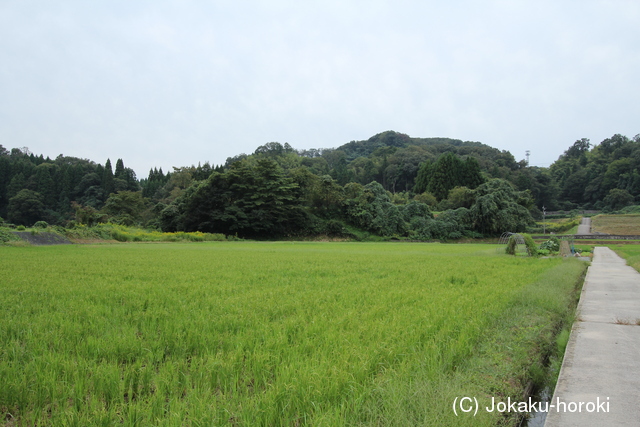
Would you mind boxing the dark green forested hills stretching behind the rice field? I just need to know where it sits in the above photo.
[0,131,640,238]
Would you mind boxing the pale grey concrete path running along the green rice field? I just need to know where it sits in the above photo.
[545,247,640,427]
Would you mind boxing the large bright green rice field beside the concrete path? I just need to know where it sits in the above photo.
[0,242,586,426]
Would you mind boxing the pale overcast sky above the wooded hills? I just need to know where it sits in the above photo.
[0,0,640,178]
